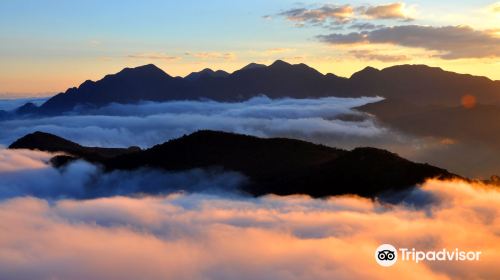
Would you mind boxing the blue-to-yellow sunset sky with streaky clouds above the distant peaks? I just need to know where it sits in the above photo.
[0,0,500,97]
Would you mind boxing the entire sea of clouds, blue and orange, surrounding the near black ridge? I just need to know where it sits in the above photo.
[0,97,500,280]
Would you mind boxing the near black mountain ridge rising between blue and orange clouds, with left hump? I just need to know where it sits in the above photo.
[11,131,456,197]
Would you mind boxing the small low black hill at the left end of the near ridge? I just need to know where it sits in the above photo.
[9,131,141,162]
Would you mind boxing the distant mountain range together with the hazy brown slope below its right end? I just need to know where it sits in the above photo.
[5,60,500,177]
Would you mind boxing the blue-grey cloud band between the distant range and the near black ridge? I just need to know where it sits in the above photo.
[0,97,388,147]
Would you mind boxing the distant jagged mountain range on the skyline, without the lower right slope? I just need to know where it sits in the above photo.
[27,60,500,114]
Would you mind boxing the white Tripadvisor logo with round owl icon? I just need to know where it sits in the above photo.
[375,244,481,267]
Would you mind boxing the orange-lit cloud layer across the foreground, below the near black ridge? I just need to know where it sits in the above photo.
[0,181,500,280]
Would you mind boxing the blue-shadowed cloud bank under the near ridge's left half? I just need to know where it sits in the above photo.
[0,149,246,200]
